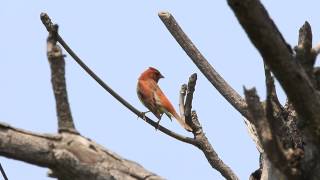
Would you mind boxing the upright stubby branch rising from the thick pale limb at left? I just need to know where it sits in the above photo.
[47,25,77,133]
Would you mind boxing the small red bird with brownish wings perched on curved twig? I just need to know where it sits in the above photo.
[137,67,192,131]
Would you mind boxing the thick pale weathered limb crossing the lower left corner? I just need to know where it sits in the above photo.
[0,121,163,180]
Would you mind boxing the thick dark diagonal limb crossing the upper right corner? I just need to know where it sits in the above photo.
[228,0,320,144]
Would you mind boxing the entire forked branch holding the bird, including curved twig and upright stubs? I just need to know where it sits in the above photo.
[41,13,238,180]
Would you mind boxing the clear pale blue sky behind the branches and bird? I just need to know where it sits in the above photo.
[0,0,320,180]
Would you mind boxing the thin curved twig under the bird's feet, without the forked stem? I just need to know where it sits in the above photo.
[40,13,195,145]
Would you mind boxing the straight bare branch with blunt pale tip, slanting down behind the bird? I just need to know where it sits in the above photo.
[159,12,247,117]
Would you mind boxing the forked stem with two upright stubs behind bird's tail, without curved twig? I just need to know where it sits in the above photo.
[180,73,238,180]
